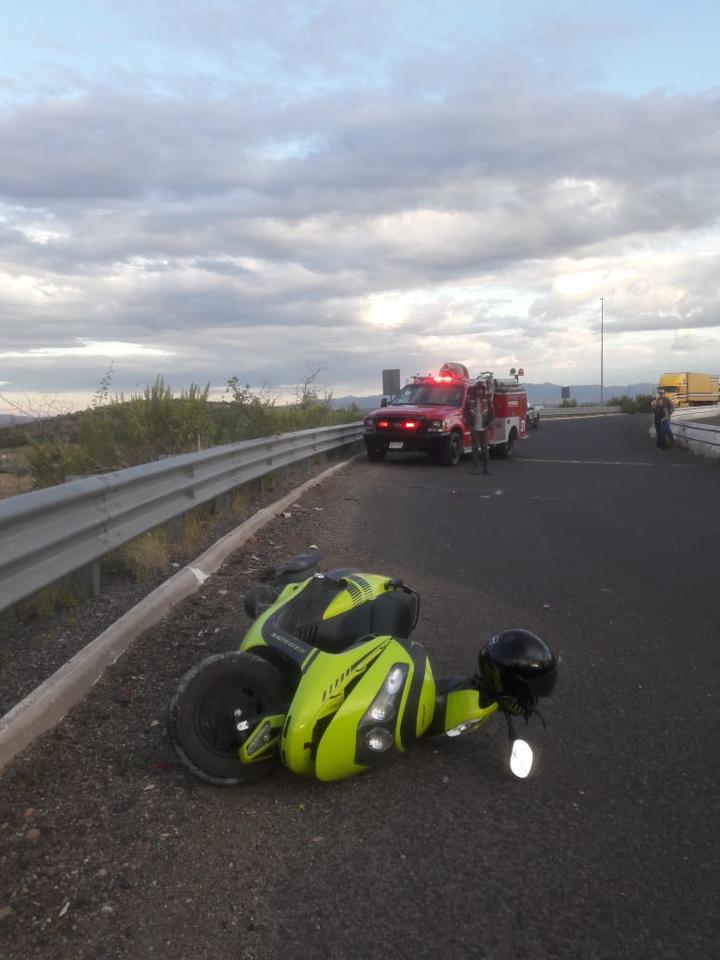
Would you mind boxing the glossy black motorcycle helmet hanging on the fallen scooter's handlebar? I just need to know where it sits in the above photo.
[478,630,557,710]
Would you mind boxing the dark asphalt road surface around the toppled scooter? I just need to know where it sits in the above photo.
[1,416,720,960]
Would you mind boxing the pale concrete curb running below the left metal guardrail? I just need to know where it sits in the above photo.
[0,457,355,770]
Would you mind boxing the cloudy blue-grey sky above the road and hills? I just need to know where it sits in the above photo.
[0,0,720,412]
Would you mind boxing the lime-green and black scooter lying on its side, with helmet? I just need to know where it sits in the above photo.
[168,549,557,785]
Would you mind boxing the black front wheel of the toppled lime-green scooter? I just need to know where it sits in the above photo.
[167,650,288,787]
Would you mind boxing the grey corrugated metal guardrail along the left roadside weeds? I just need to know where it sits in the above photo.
[0,423,362,610]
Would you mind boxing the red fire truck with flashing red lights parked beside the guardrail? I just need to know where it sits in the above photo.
[364,362,527,466]
